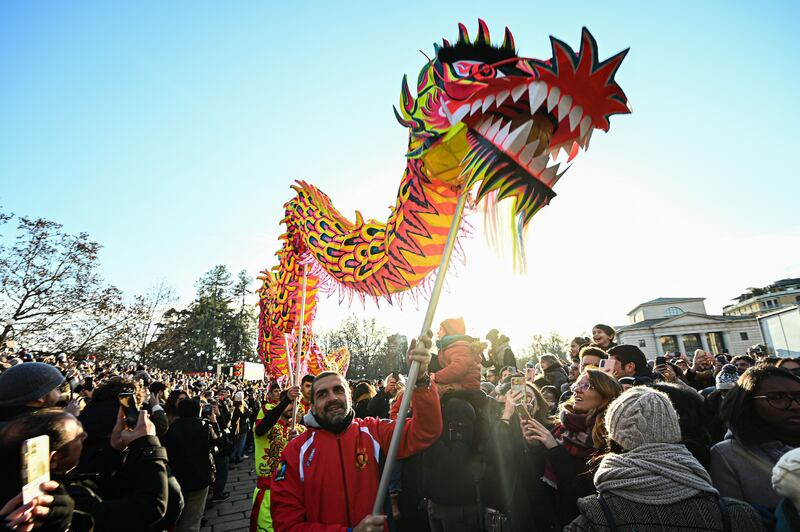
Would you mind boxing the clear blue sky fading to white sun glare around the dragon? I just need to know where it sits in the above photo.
[0,1,800,344]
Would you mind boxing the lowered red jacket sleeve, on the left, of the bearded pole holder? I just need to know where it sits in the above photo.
[270,440,347,532]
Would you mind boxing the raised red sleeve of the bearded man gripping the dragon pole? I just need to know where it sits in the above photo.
[365,384,442,458]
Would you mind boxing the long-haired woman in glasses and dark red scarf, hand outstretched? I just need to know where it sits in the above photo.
[523,369,622,525]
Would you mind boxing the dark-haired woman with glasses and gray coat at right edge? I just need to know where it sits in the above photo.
[710,364,800,508]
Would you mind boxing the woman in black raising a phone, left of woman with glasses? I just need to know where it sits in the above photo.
[483,375,560,532]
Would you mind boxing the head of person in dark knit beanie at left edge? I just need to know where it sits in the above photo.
[0,362,65,428]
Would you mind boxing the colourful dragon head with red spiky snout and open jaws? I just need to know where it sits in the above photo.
[395,20,630,224]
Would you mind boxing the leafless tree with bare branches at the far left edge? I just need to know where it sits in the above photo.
[0,215,130,353]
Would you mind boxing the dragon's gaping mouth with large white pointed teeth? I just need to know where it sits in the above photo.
[450,80,593,188]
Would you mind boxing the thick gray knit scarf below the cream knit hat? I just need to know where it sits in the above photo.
[594,443,719,506]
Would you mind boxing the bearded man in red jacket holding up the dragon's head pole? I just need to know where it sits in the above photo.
[270,336,442,532]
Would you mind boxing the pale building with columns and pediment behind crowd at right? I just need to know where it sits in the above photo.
[616,297,764,359]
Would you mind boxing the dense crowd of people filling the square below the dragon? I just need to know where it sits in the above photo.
[0,318,800,532]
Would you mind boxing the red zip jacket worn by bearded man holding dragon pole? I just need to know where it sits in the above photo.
[270,384,442,532]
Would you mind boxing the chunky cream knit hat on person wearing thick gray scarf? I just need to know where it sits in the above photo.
[606,386,681,451]
